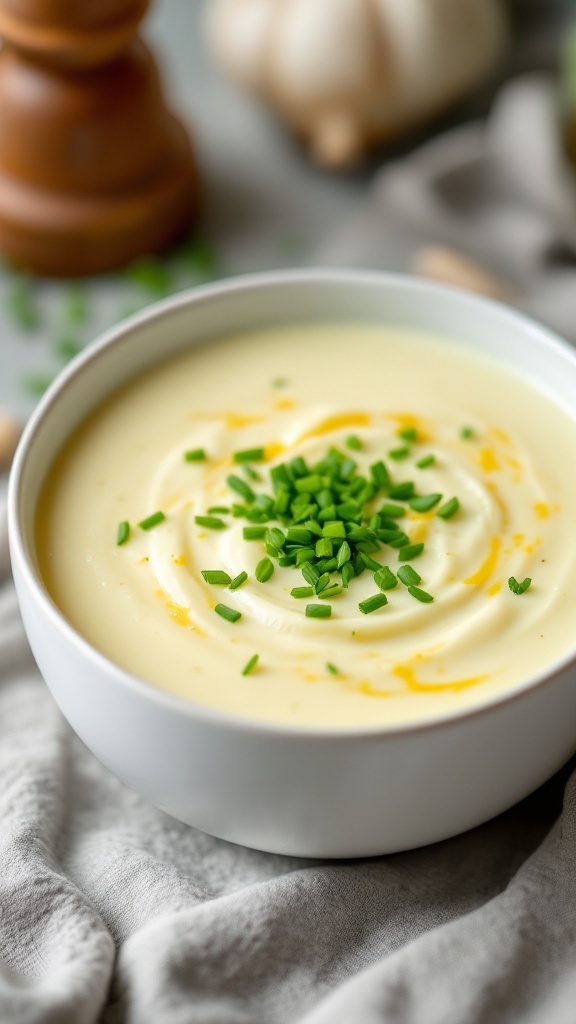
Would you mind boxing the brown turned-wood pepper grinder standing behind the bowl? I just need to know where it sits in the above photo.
[0,0,198,276]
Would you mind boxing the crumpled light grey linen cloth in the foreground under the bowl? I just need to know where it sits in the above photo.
[0,487,576,1024]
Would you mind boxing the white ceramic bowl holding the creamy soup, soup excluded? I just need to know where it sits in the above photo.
[9,270,576,857]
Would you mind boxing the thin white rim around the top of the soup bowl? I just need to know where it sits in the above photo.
[7,267,576,742]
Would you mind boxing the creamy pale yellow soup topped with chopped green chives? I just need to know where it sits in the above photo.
[37,324,576,728]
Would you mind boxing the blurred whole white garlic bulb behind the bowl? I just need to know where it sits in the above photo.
[206,0,506,167]
